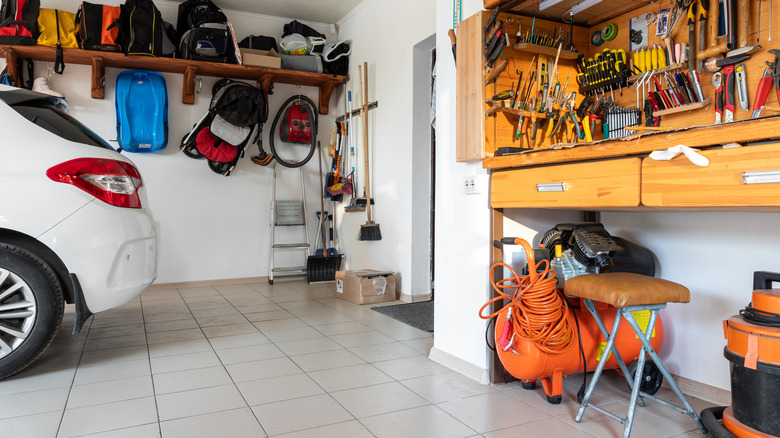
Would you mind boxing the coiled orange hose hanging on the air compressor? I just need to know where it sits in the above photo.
[479,238,576,353]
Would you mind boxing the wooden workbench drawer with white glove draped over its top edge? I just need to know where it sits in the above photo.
[642,143,780,207]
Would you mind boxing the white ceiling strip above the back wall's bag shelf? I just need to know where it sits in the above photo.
[219,0,362,24]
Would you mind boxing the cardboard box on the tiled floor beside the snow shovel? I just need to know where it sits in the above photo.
[336,269,397,304]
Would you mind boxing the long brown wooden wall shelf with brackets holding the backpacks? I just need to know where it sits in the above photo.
[0,46,347,114]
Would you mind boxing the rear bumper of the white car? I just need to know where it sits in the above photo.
[38,200,157,313]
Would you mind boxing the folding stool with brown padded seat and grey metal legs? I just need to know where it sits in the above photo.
[565,272,707,438]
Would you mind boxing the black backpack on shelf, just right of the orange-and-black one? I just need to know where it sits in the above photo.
[120,0,163,56]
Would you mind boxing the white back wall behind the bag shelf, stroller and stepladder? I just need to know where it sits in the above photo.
[3,0,341,283]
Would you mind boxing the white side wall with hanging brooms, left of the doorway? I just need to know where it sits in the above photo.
[334,0,436,295]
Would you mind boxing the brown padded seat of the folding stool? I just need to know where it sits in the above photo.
[564,272,691,308]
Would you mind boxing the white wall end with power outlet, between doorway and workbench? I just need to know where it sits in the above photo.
[431,0,491,382]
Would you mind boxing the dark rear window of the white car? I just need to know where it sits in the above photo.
[12,102,114,150]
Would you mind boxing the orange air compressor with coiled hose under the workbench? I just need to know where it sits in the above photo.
[480,224,664,404]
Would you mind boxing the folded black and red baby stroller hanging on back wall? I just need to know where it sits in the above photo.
[180,79,268,176]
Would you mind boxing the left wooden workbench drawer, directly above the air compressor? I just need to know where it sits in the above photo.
[490,158,642,208]
